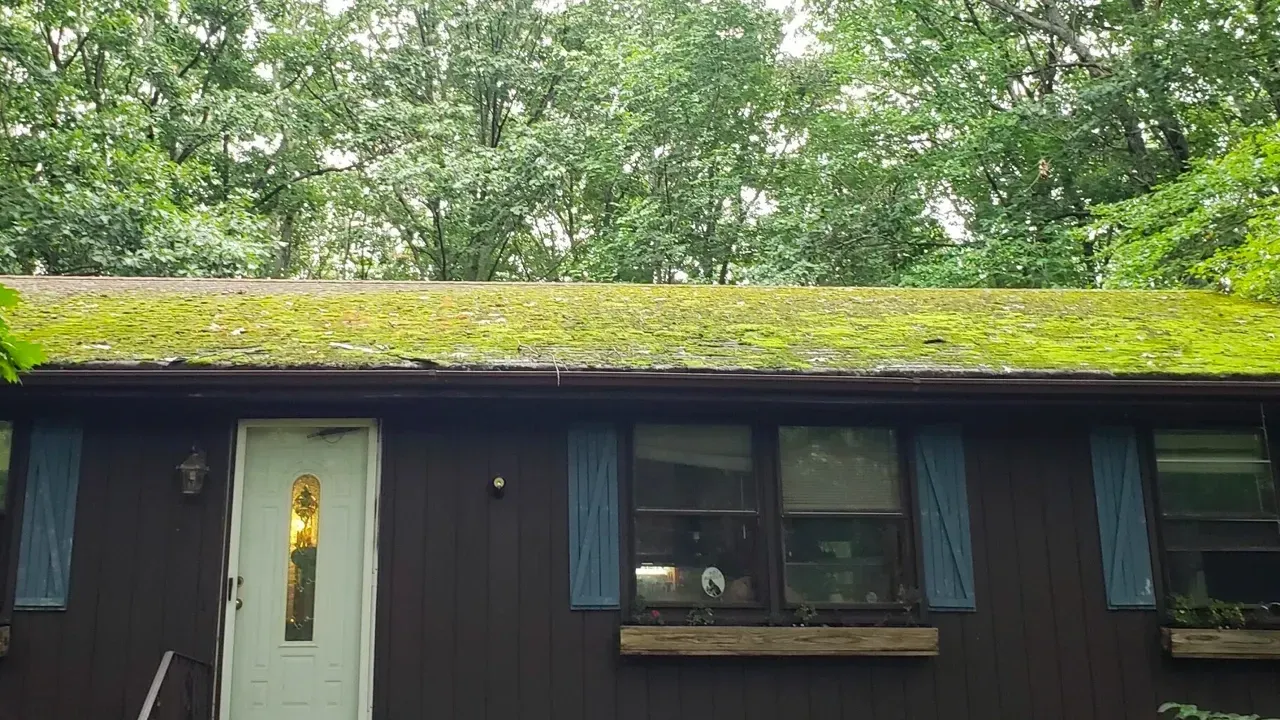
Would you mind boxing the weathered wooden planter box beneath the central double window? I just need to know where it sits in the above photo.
[618,625,938,657]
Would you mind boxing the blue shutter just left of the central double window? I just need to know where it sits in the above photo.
[568,425,621,610]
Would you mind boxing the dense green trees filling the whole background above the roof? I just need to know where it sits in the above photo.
[0,0,1280,288]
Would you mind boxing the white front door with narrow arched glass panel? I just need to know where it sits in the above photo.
[221,421,376,720]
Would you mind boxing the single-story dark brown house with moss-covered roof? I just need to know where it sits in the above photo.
[0,278,1280,720]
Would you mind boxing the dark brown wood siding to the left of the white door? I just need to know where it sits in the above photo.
[0,413,230,720]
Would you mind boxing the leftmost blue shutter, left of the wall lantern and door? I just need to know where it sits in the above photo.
[14,423,81,609]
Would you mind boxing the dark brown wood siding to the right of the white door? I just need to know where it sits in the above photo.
[375,412,1280,720]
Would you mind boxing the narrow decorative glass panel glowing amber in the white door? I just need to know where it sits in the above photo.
[284,475,320,642]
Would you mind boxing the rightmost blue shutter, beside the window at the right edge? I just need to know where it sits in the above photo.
[1089,428,1156,610]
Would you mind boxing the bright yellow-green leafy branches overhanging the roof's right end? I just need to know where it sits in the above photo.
[1091,124,1280,301]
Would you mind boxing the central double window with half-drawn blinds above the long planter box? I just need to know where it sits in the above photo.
[631,425,911,610]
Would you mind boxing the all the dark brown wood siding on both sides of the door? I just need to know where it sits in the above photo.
[0,399,1280,720]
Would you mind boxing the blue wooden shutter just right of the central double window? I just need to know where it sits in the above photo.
[915,425,977,610]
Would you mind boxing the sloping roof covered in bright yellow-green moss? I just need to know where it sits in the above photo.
[0,278,1280,378]
